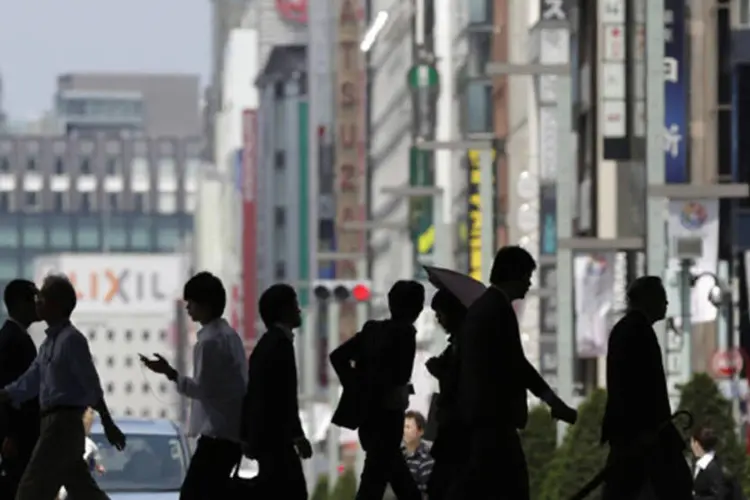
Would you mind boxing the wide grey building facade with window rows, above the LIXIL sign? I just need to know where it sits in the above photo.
[0,135,203,316]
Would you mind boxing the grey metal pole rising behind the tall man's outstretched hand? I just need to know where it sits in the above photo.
[556,76,577,444]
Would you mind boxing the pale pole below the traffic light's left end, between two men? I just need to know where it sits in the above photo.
[302,306,318,490]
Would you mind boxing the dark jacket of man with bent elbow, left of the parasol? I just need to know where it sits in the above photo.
[330,319,417,429]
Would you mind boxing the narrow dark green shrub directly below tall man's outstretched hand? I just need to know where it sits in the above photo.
[521,405,557,500]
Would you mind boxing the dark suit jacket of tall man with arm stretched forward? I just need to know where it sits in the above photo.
[458,287,550,429]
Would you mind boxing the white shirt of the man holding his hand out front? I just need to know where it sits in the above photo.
[177,319,247,442]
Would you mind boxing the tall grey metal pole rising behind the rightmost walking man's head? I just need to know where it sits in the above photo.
[646,0,672,356]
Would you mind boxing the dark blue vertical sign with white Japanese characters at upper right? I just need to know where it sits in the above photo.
[664,0,689,184]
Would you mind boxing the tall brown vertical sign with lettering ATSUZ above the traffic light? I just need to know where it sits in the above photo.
[338,0,366,340]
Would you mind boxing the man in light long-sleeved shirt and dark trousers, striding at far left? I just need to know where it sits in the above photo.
[0,276,126,500]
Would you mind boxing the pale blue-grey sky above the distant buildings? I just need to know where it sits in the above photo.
[0,0,211,120]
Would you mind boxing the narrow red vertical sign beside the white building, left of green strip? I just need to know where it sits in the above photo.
[247,109,258,351]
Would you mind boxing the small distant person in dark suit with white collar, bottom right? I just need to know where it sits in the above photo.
[690,427,734,500]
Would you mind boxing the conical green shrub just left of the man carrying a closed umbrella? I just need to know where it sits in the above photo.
[539,389,609,500]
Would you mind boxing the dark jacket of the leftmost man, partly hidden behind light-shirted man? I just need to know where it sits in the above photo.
[0,320,39,454]
